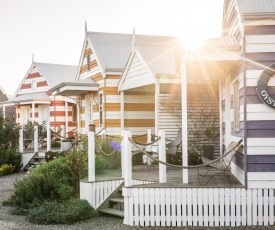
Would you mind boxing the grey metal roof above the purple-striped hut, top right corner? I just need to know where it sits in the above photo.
[237,0,275,15]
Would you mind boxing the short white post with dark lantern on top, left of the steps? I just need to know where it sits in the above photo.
[88,131,95,182]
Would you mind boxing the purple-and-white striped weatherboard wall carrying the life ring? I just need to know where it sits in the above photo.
[240,18,275,173]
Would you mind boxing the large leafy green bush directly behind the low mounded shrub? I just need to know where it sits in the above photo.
[11,157,75,209]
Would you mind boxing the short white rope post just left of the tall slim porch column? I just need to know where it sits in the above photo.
[158,130,167,183]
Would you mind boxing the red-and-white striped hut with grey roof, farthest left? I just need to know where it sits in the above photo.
[5,62,77,135]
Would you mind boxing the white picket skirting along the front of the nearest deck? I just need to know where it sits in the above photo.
[123,187,275,226]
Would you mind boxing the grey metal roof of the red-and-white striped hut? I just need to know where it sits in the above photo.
[34,62,77,87]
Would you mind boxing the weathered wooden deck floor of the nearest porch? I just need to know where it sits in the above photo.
[96,165,243,188]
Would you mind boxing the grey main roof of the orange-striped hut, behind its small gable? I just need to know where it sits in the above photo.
[87,32,177,71]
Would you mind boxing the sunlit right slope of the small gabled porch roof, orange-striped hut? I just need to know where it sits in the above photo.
[136,45,176,75]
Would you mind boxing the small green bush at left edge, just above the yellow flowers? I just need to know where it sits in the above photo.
[0,149,22,172]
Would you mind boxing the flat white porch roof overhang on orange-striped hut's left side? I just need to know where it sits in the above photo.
[49,79,98,96]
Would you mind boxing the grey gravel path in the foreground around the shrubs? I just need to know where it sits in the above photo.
[0,173,275,230]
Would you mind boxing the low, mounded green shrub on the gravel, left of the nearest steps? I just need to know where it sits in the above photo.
[28,199,94,224]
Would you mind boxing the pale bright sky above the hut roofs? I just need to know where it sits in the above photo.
[0,0,223,95]
